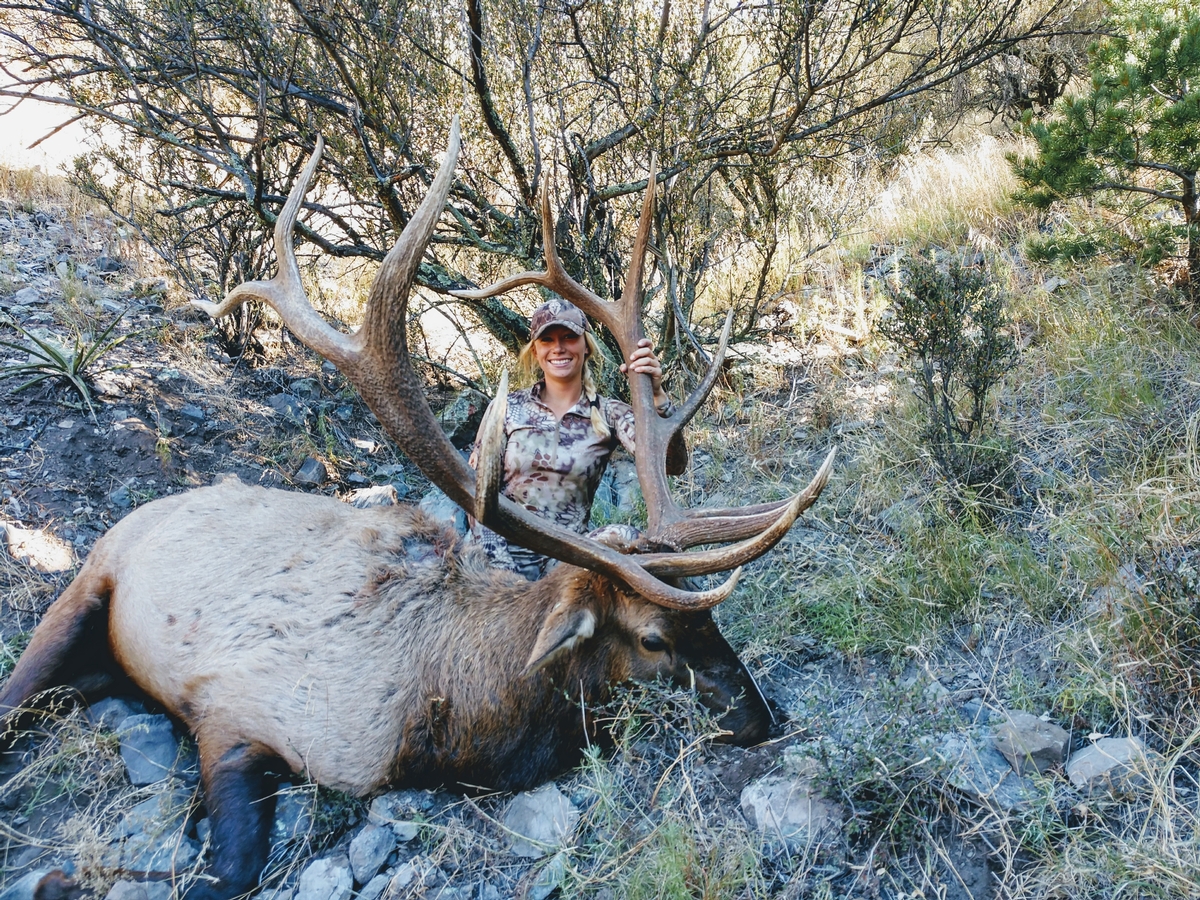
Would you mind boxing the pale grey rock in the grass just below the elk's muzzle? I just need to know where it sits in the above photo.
[742,774,845,850]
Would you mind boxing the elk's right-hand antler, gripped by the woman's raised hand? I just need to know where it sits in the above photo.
[450,157,835,577]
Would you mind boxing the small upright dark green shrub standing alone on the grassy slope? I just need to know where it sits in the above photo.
[882,256,1016,486]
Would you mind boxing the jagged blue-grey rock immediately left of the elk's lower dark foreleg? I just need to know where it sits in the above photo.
[103,787,200,872]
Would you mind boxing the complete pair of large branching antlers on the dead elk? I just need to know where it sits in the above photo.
[193,116,834,610]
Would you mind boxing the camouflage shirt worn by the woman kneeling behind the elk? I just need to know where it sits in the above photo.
[470,382,688,577]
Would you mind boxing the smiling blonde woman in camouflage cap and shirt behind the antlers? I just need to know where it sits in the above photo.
[470,298,688,581]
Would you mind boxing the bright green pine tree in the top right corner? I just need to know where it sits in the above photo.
[1013,0,1200,301]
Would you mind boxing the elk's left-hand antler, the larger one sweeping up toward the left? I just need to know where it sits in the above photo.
[193,116,777,610]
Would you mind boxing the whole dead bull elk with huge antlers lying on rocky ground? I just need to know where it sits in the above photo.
[0,119,833,899]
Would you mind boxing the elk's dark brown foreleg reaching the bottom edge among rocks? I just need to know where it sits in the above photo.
[187,738,281,900]
